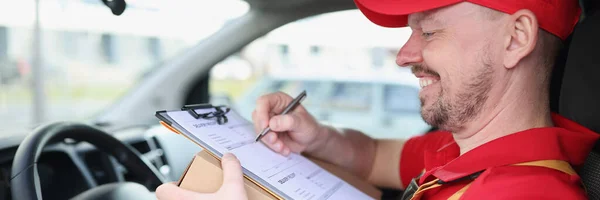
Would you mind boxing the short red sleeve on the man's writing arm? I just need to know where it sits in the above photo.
[399,131,454,188]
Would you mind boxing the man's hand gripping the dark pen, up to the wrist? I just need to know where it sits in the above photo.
[252,92,324,155]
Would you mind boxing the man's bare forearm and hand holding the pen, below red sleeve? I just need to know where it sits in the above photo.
[252,92,404,188]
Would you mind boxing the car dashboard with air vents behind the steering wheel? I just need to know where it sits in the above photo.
[0,126,201,200]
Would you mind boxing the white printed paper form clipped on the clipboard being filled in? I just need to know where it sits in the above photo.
[168,109,372,200]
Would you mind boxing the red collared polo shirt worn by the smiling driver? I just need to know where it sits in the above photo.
[400,114,600,199]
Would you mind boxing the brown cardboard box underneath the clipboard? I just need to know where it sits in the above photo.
[178,151,381,200]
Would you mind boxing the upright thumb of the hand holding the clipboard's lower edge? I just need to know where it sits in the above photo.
[221,153,244,188]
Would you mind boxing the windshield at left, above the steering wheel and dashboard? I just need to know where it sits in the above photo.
[0,0,248,134]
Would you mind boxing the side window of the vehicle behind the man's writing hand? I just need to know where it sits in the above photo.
[209,10,429,138]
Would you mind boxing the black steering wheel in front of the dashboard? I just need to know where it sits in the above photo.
[11,122,165,200]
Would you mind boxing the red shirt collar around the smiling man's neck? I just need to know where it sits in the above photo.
[422,114,600,182]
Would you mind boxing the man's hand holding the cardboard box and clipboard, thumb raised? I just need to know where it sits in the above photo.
[156,153,248,200]
